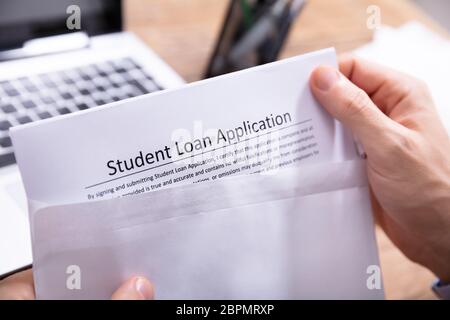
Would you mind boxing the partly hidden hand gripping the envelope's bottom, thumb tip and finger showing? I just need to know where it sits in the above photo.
[0,269,154,300]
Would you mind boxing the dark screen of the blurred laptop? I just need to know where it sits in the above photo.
[0,0,122,50]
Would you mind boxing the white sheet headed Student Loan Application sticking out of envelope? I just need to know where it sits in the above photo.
[12,49,356,204]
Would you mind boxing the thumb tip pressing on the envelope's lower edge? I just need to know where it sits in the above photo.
[111,277,154,300]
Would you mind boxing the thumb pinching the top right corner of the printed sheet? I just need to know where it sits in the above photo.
[310,66,392,146]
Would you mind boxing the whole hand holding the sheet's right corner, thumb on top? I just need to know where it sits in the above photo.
[310,57,450,282]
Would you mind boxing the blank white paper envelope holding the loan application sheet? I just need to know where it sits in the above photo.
[33,161,383,299]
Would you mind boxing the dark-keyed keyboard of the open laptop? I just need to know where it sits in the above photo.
[0,58,162,167]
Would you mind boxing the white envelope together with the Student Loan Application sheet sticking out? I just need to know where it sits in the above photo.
[11,49,383,299]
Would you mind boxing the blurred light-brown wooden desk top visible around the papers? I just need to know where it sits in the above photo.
[125,0,446,299]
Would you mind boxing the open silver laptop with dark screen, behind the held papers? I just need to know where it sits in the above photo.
[0,0,184,276]
